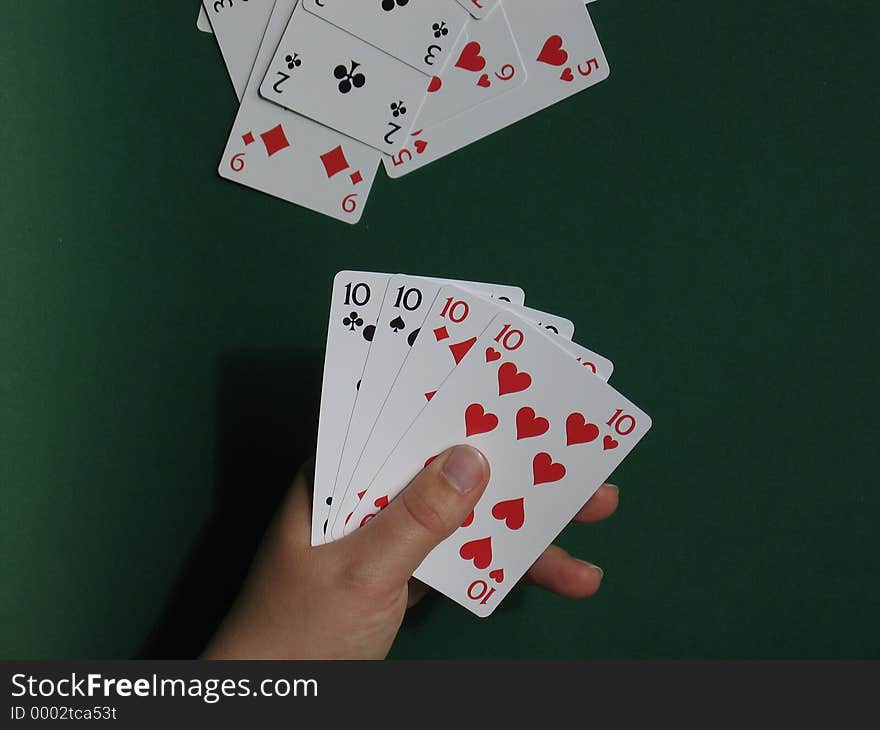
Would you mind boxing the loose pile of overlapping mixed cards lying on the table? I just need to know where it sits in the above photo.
[199,0,608,223]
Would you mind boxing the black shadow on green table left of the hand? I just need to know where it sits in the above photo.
[138,351,322,659]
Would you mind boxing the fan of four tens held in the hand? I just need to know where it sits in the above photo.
[312,271,651,616]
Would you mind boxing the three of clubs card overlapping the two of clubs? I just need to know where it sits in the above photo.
[303,0,470,76]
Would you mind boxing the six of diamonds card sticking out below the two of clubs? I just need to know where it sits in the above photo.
[219,0,381,223]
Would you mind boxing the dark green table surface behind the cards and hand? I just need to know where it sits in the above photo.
[0,0,880,658]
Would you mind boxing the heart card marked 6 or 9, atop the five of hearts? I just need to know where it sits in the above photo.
[415,6,526,129]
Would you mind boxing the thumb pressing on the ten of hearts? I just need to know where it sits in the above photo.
[349,446,489,583]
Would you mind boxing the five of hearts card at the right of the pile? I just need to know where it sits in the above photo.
[384,0,609,178]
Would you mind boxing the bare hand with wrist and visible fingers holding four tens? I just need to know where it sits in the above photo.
[203,446,619,659]
